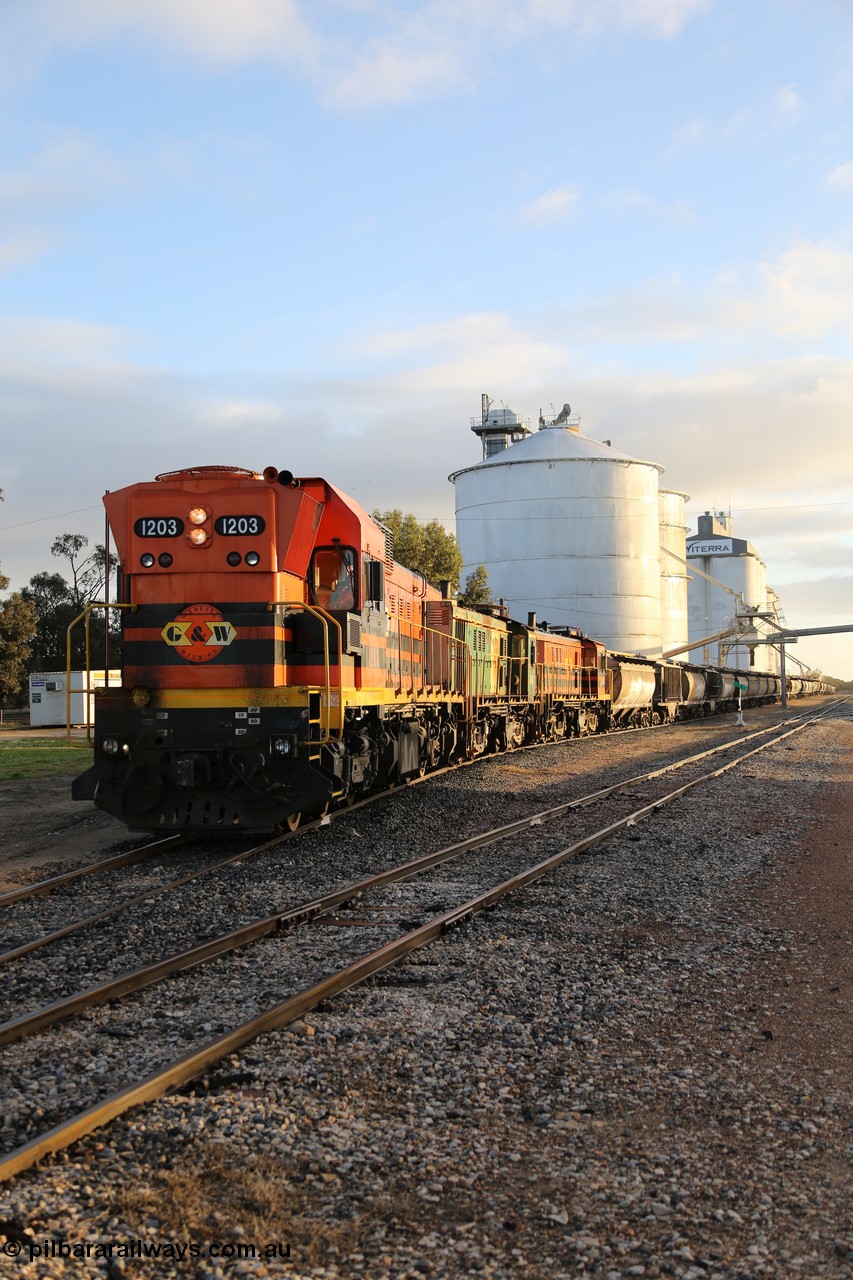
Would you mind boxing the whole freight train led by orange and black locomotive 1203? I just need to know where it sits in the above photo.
[73,466,818,832]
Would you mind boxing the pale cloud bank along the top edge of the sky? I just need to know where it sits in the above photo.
[6,0,713,108]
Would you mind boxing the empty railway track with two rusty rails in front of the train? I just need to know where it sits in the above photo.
[0,704,838,1179]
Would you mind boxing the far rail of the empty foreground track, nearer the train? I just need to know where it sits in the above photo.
[0,708,829,1046]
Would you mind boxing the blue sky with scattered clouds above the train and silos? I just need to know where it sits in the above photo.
[0,0,853,678]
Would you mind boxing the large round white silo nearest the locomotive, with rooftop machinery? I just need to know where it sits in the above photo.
[450,404,663,654]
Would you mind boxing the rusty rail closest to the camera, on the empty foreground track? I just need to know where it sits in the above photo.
[0,701,821,1181]
